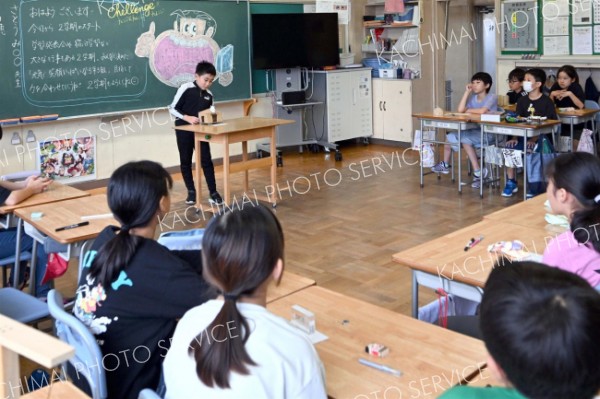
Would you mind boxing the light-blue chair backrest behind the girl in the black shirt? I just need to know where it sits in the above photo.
[48,290,107,399]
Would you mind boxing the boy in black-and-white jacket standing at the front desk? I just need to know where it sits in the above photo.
[169,61,223,205]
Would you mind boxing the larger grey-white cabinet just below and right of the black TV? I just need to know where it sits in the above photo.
[307,68,373,143]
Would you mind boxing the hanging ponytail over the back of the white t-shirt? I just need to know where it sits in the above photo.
[188,294,256,389]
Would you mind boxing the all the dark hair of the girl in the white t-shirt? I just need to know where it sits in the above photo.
[188,205,283,388]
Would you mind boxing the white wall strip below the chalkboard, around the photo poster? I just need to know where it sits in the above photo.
[0,96,273,179]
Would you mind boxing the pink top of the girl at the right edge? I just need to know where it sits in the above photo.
[542,230,600,287]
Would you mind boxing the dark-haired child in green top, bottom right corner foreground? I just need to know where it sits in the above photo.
[440,262,600,399]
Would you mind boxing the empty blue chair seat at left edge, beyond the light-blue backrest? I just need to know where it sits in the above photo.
[0,287,50,324]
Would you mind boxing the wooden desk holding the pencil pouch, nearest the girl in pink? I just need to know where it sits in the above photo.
[392,219,555,317]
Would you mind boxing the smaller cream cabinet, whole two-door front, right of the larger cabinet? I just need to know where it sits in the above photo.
[373,79,413,143]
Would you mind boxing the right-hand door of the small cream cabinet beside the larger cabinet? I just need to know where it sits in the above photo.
[383,79,412,143]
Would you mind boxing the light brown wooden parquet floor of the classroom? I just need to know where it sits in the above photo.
[57,142,522,315]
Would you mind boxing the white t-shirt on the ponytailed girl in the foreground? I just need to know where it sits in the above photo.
[163,300,327,399]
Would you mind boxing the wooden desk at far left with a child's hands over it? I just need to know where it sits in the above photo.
[0,182,90,290]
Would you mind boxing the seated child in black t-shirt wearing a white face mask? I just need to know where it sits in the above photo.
[502,68,558,197]
